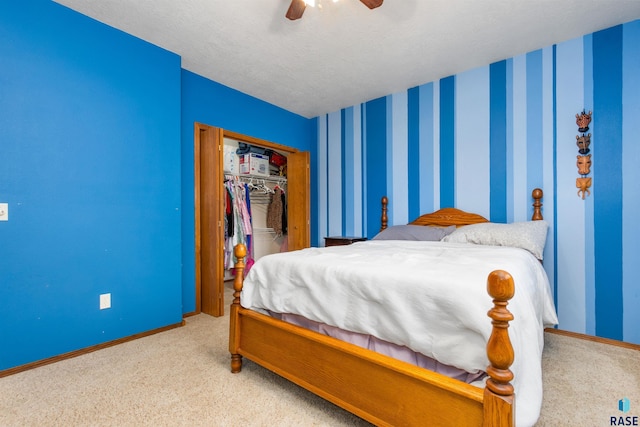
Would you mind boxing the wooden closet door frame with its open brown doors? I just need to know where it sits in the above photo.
[194,123,311,317]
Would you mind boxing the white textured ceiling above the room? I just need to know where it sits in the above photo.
[56,0,640,117]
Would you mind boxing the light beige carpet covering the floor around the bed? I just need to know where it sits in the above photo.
[0,290,640,427]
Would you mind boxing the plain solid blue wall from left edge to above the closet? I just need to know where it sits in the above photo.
[0,0,316,370]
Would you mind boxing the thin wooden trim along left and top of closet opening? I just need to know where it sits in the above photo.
[193,122,300,316]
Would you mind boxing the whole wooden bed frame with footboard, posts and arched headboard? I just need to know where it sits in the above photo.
[229,189,542,427]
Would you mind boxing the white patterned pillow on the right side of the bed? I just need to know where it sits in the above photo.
[442,221,549,260]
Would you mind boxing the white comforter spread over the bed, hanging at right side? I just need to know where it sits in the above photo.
[241,240,557,426]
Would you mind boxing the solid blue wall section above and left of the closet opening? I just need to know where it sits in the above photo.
[182,70,316,313]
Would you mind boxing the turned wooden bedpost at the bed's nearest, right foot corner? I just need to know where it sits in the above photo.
[484,270,515,427]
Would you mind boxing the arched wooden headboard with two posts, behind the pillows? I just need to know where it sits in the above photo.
[380,188,543,231]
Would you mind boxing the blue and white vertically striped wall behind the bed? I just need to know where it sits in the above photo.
[314,21,640,343]
